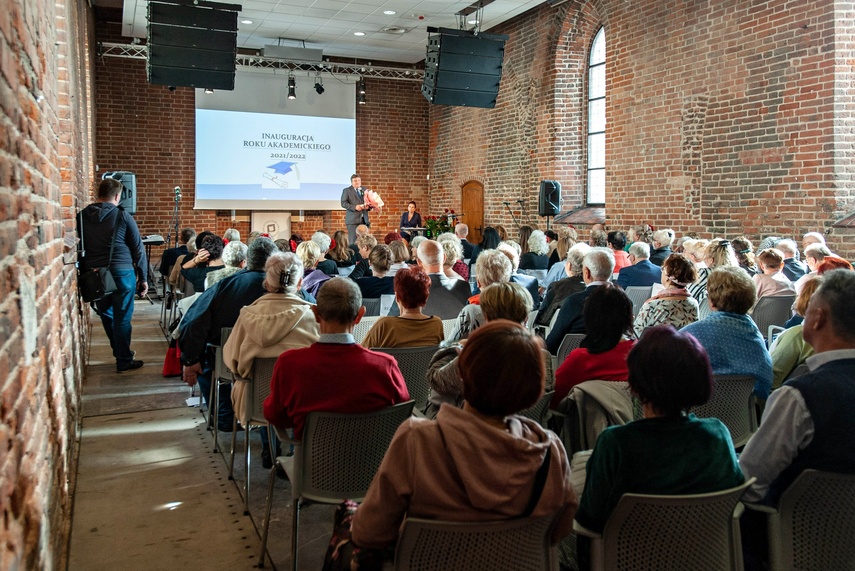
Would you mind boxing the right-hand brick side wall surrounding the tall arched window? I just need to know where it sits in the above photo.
[430,0,855,258]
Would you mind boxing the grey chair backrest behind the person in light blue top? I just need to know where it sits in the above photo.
[692,375,757,447]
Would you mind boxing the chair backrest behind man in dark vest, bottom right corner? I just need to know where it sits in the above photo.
[778,470,855,571]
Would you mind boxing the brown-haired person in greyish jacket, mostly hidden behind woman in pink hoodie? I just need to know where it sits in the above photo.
[425,282,554,418]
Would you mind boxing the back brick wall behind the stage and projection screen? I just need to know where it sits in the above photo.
[95,16,428,258]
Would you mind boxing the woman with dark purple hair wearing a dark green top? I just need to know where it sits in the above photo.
[576,324,744,540]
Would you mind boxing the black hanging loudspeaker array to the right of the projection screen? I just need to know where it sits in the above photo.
[422,28,508,109]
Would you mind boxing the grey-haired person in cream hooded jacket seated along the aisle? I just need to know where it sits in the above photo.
[223,255,320,468]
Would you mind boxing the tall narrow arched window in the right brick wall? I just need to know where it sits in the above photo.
[586,28,606,204]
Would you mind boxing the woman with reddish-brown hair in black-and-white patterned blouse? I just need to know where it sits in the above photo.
[635,254,699,337]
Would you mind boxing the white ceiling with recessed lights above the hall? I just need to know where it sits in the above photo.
[122,0,544,63]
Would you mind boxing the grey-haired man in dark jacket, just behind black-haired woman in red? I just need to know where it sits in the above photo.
[546,248,616,355]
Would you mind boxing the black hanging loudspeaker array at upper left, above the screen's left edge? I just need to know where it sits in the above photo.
[147,0,241,91]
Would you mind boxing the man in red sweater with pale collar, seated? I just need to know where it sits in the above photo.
[264,278,410,439]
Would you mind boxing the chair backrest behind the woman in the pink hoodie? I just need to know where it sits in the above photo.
[394,517,558,571]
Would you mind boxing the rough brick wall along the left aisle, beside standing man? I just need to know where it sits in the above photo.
[0,0,92,570]
